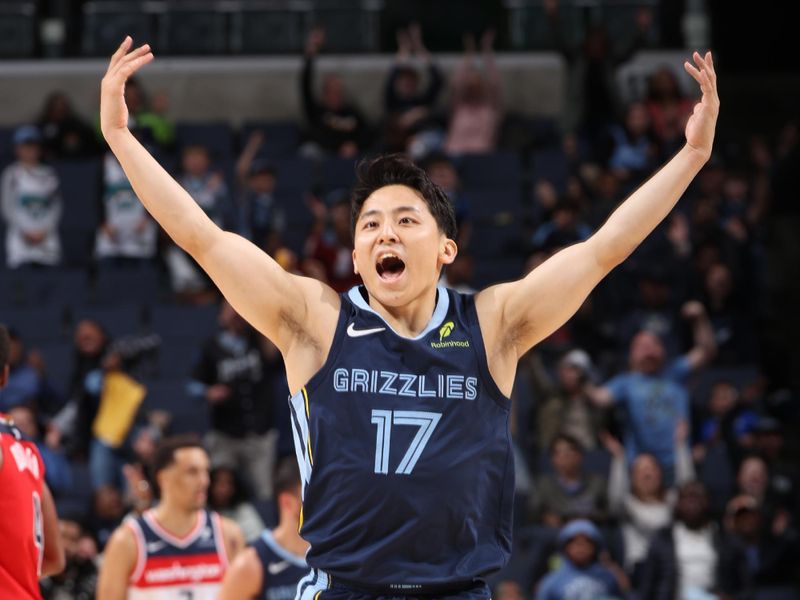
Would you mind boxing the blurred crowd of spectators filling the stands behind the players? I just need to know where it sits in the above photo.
[0,14,800,600]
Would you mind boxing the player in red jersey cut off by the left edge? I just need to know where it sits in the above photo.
[0,325,66,600]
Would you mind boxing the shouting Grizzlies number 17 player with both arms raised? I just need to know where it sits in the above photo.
[101,38,719,600]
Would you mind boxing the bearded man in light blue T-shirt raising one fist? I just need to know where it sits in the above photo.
[588,302,714,485]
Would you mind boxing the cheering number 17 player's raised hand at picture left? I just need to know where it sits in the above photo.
[100,36,153,140]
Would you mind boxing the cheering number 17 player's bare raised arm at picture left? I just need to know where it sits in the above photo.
[100,37,339,366]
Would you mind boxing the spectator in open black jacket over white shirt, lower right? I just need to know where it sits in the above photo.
[638,482,751,600]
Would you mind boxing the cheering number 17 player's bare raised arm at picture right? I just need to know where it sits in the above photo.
[478,52,719,388]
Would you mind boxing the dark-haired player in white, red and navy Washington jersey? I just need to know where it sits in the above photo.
[97,436,244,600]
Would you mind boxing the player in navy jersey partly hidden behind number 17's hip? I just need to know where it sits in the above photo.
[217,459,308,600]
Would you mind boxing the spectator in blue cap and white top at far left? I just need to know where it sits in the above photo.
[0,125,62,269]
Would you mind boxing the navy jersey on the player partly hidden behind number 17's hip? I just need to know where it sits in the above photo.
[252,531,308,600]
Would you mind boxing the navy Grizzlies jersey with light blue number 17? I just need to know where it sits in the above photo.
[290,287,514,594]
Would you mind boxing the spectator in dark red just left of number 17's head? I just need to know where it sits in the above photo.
[303,193,361,292]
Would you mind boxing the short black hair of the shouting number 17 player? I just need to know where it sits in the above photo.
[350,154,458,240]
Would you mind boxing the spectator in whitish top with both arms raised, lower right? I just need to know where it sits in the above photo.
[603,421,694,581]
